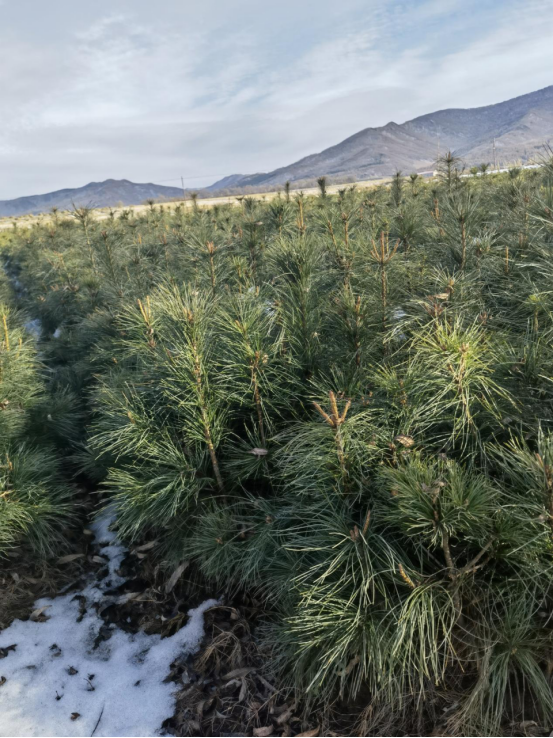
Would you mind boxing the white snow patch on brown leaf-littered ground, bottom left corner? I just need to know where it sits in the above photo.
[0,516,216,736]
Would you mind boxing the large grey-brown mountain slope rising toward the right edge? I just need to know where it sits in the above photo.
[215,86,553,189]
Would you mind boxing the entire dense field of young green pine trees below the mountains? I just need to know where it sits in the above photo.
[0,155,553,735]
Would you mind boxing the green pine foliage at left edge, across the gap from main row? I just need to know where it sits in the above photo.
[0,282,74,555]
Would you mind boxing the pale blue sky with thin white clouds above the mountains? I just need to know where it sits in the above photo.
[0,0,553,199]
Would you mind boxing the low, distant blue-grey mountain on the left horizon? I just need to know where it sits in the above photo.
[0,179,182,216]
